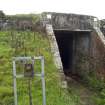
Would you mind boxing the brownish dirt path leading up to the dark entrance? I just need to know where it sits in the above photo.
[67,78,96,105]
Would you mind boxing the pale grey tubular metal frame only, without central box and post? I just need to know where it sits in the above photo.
[13,56,46,105]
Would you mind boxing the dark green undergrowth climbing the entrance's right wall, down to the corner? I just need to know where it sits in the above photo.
[76,53,105,105]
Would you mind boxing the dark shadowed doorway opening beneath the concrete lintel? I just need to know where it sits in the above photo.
[54,30,90,76]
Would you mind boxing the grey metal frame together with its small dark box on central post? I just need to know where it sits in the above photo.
[13,56,46,105]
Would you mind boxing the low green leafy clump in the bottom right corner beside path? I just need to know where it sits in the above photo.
[87,73,105,105]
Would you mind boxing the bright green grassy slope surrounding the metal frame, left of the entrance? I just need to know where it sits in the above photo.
[0,31,103,105]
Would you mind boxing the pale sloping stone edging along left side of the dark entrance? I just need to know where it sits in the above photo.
[46,24,67,88]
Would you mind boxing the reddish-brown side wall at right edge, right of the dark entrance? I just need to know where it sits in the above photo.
[89,31,105,79]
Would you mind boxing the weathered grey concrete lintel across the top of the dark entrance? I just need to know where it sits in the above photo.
[43,13,95,31]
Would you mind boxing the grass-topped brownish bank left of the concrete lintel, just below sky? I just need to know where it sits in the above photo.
[0,11,41,31]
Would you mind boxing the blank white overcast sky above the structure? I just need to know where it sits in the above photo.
[0,0,105,19]
